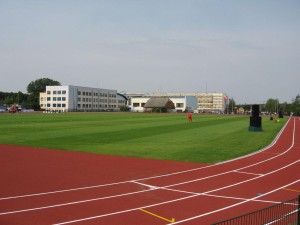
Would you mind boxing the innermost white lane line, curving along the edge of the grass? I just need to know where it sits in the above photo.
[0,117,295,201]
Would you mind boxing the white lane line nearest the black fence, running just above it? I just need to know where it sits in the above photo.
[167,179,300,225]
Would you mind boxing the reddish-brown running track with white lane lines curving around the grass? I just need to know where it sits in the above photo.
[0,117,300,225]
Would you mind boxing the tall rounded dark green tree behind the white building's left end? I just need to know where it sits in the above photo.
[27,78,61,110]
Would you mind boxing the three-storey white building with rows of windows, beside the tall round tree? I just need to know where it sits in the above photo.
[40,85,126,112]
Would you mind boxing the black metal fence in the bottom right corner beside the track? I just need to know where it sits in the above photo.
[212,195,300,225]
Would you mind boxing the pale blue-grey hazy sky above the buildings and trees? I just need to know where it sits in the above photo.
[0,0,300,104]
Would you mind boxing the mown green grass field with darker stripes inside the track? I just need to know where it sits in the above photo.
[0,113,287,163]
